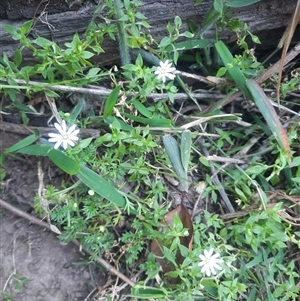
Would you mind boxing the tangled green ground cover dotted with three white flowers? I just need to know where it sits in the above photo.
[0,0,300,300]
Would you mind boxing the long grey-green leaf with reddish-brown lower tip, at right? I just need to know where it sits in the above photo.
[246,79,291,158]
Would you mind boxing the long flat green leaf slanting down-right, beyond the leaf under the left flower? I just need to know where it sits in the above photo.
[77,164,126,208]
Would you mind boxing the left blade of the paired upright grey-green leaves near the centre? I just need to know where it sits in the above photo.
[163,135,189,191]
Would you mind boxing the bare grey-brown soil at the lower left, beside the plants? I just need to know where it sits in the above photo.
[0,133,107,301]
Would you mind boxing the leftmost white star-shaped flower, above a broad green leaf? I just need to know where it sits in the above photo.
[48,120,79,149]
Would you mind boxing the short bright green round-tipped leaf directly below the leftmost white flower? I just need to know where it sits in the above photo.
[48,149,79,175]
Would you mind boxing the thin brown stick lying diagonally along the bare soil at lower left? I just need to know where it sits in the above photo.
[0,199,135,286]
